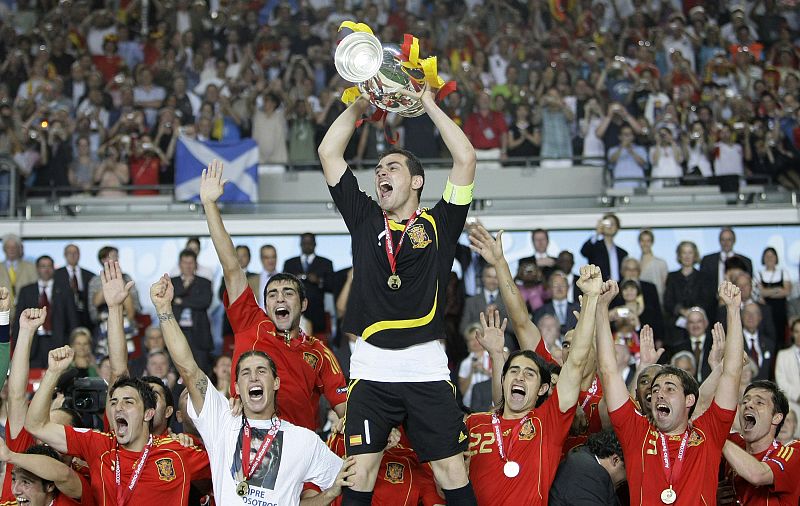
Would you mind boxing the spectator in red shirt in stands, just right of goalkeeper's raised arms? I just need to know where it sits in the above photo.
[464,93,508,170]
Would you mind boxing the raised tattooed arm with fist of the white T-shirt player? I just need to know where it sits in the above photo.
[150,274,208,413]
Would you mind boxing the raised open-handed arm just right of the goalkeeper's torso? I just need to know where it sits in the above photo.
[469,225,542,351]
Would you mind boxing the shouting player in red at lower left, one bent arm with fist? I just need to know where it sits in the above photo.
[25,346,211,506]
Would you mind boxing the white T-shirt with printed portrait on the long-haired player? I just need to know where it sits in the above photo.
[187,382,342,506]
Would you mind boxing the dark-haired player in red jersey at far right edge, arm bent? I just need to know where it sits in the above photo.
[723,380,800,506]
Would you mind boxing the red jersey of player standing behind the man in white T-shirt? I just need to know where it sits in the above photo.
[224,286,347,430]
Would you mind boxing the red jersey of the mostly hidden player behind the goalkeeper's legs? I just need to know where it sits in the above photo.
[328,434,444,506]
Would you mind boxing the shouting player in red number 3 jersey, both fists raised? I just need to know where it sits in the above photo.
[597,282,744,505]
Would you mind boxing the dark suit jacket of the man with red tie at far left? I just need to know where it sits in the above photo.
[14,281,79,368]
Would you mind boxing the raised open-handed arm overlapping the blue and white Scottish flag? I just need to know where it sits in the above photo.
[200,160,247,302]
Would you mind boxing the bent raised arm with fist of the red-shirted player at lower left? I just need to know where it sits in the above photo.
[25,346,75,453]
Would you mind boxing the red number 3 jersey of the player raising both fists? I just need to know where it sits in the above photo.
[609,399,736,506]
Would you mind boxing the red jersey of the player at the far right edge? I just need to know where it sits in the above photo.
[726,433,800,506]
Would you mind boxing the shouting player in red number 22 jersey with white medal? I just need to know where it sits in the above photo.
[467,265,604,505]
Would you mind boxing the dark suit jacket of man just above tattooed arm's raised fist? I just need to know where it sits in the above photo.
[172,276,214,354]
